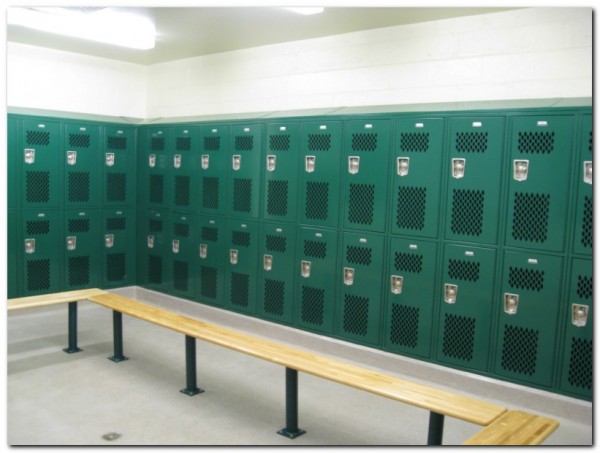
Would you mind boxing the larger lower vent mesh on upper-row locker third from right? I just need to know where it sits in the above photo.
[450,189,485,236]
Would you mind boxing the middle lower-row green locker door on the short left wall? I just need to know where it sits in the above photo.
[63,209,100,291]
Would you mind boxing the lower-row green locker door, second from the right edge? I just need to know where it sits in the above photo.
[495,251,562,387]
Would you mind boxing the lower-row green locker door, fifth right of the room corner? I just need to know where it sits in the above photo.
[257,223,296,324]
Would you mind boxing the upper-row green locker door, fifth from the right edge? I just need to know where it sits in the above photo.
[343,120,391,232]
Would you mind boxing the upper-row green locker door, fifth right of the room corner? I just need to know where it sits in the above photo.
[263,123,300,222]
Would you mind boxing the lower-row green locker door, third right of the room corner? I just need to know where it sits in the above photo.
[197,216,228,306]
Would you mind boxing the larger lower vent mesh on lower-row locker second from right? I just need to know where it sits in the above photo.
[502,325,539,376]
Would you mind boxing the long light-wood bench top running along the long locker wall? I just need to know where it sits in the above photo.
[89,293,506,425]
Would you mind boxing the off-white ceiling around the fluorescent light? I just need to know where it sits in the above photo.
[7,6,513,65]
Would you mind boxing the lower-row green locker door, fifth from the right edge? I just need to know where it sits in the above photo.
[336,233,387,346]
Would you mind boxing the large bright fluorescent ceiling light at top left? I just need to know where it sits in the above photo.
[7,7,156,50]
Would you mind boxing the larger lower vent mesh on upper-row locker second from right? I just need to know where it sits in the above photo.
[512,192,550,242]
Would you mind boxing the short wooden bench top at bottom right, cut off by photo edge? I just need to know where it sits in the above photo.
[465,410,558,445]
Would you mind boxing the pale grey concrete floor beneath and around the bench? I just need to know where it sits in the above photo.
[6,288,593,446]
